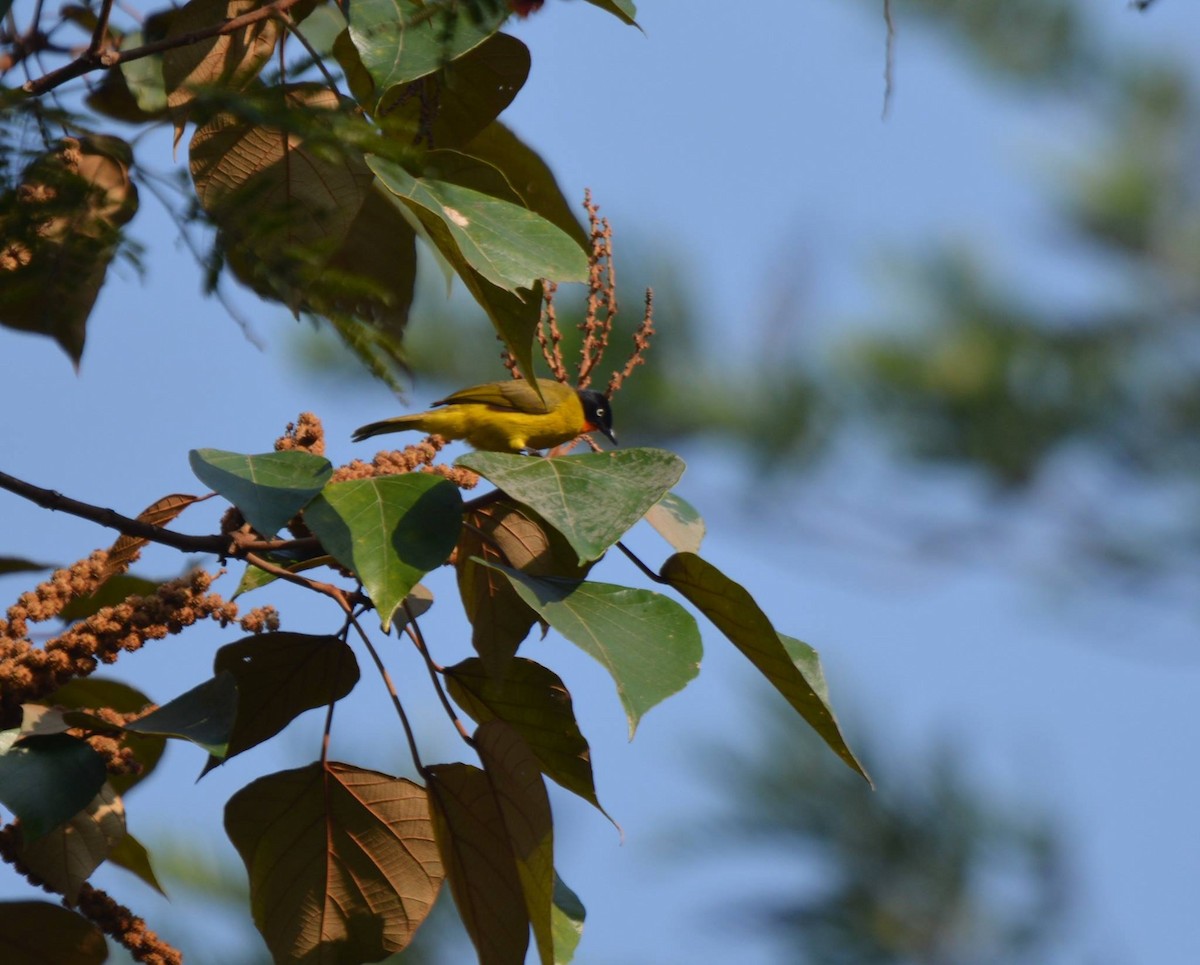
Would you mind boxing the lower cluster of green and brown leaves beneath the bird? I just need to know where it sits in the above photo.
[0,449,866,965]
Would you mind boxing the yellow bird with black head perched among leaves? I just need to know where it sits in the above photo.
[353,378,617,452]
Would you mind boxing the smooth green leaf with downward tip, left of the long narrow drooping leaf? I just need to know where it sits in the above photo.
[496,567,703,739]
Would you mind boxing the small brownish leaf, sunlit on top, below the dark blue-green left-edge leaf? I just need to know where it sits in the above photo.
[20,785,125,904]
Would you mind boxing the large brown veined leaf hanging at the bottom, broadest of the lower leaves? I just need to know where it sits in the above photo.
[224,762,443,965]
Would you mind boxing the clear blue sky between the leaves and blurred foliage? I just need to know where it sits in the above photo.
[0,0,1200,965]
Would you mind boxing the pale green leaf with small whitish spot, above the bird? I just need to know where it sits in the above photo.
[367,156,588,292]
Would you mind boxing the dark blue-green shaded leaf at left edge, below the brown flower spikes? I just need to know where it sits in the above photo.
[0,730,107,843]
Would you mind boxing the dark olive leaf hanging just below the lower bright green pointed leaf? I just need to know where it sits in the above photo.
[445,657,611,820]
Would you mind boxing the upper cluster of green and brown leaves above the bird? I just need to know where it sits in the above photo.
[0,0,634,377]
